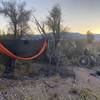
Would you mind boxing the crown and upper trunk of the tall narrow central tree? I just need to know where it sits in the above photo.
[46,5,61,47]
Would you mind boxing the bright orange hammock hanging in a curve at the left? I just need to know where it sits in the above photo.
[0,40,48,60]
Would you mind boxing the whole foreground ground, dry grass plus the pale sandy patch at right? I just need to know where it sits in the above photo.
[0,68,100,100]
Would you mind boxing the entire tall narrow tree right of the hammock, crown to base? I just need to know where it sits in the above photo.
[46,5,62,63]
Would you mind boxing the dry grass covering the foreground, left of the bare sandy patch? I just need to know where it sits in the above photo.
[0,76,100,100]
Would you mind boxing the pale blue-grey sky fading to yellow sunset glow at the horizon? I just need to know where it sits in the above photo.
[0,0,100,34]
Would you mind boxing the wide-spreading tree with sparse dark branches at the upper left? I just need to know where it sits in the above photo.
[0,0,31,36]
